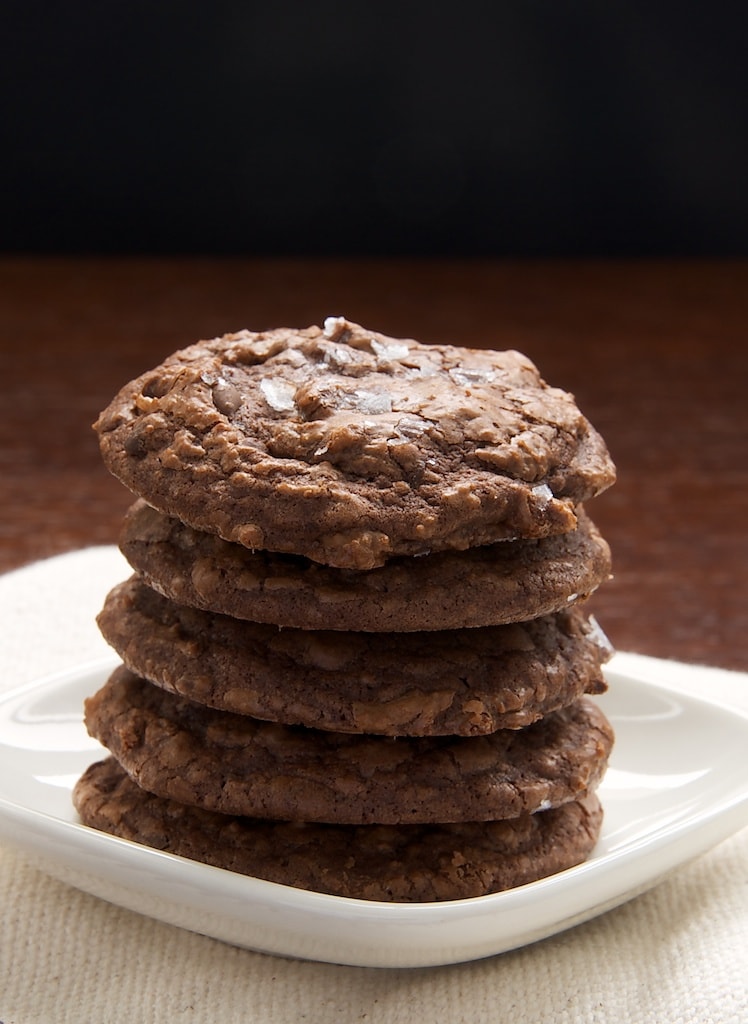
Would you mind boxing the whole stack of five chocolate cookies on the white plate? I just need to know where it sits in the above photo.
[74,316,615,901]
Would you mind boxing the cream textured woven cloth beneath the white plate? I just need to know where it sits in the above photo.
[0,548,748,1024]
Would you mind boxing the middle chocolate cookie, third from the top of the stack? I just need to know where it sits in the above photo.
[97,577,611,736]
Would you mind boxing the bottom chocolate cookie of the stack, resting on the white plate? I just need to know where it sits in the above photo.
[74,759,602,903]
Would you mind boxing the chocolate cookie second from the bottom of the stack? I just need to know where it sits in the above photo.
[85,668,613,824]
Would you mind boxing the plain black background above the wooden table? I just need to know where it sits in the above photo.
[5,0,748,257]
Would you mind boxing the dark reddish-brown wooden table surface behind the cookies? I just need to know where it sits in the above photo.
[0,259,748,670]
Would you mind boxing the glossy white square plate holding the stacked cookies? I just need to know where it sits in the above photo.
[0,659,748,967]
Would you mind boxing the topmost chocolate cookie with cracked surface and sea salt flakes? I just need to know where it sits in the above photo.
[95,317,615,569]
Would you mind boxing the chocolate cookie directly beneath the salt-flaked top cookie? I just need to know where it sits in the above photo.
[120,501,611,632]
